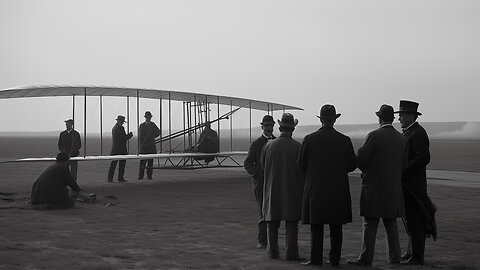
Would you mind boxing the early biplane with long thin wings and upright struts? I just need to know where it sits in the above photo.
[0,86,303,168]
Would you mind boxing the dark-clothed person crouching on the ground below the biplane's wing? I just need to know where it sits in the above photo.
[30,152,81,209]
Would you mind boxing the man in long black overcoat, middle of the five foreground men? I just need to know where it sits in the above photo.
[298,104,357,266]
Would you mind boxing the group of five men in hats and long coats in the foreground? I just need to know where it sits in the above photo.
[244,100,436,266]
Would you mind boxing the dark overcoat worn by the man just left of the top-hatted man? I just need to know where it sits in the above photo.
[357,125,405,218]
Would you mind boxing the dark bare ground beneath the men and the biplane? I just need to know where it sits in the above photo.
[0,159,480,269]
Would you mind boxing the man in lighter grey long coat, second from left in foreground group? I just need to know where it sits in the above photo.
[260,113,304,261]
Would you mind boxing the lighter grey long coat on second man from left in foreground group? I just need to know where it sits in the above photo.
[260,134,305,221]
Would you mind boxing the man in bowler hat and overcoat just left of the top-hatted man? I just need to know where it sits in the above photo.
[347,104,405,266]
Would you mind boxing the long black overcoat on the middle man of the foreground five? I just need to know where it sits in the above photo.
[298,127,357,224]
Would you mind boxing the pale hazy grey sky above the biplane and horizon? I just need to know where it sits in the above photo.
[0,0,480,131]
